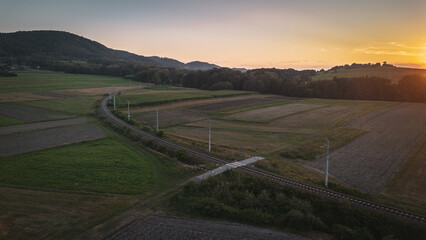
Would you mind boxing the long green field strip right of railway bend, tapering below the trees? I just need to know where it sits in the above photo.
[116,90,251,108]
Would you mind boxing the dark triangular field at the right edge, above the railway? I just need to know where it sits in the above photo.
[383,138,426,206]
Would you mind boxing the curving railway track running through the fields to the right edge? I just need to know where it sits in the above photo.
[100,91,426,224]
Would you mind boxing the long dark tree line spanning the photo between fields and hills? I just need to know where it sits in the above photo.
[2,58,426,102]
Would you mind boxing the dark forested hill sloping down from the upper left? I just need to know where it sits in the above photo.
[0,31,218,70]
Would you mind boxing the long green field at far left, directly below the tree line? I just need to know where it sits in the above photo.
[0,71,138,93]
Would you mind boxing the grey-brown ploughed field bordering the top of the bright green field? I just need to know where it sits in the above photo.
[0,125,106,157]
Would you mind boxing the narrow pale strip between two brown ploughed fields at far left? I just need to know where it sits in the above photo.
[0,117,88,135]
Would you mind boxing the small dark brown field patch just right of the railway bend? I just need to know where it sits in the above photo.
[134,109,207,128]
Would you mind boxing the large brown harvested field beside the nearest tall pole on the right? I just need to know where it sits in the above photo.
[306,103,426,193]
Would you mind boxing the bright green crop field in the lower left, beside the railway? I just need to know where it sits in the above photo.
[0,138,190,195]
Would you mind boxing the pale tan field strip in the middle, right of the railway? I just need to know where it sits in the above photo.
[228,103,326,122]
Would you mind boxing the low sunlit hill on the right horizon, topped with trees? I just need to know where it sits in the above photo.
[312,63,426,83]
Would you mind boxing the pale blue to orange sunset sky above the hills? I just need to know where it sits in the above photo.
[0,0,426,69]
